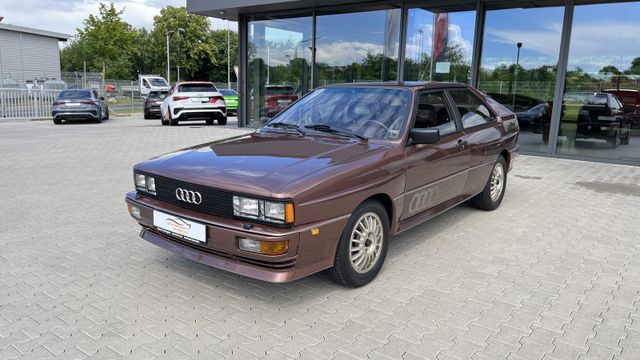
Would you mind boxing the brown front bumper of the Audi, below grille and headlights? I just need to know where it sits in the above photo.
[125,192,349,283]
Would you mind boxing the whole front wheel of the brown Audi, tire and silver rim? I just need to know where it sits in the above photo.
[328,200,389,287]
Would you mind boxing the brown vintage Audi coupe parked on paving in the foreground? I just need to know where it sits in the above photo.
[126,83,519,286]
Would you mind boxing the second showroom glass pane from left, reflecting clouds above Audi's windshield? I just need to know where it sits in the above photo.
[316,9,401,86]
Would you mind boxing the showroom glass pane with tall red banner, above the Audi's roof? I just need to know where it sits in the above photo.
[404,8,476,83]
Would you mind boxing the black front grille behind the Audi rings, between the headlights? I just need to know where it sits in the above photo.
[144,174,233,218]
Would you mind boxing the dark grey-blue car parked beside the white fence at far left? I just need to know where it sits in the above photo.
[51,89,109,125]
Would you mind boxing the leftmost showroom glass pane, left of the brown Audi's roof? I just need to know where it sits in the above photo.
[246,17,313,126]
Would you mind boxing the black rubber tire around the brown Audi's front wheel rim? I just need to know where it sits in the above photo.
[328,200,389,287]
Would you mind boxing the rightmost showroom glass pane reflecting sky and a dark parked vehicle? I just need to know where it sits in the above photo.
[557,2,640,161]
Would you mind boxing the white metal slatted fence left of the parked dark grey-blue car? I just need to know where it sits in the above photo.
[0,88,60,119]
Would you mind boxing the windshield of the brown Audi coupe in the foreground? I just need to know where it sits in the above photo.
[266,86,411,140]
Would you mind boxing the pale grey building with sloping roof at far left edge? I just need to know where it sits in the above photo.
[0,19,70,87]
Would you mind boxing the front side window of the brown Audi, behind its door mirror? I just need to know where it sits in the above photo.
[413,92,457,136]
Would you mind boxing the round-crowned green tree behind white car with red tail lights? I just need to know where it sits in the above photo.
[151,6,218,79]
